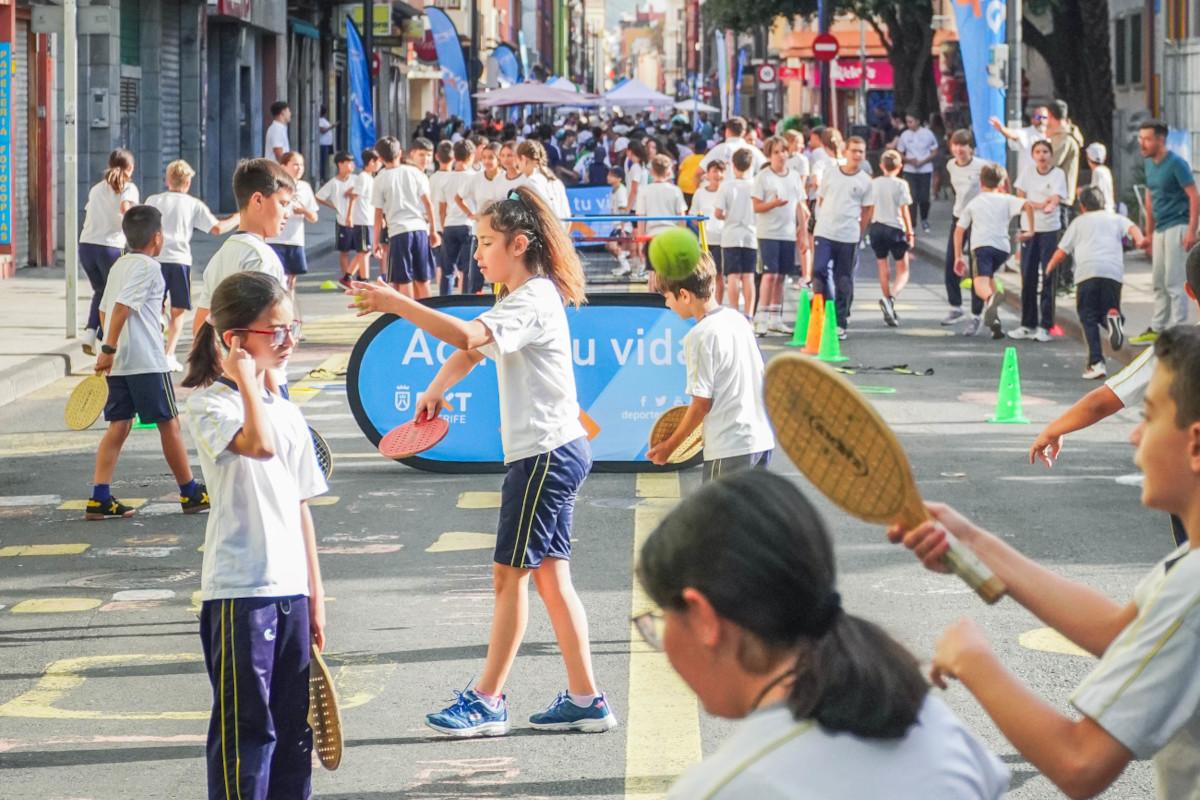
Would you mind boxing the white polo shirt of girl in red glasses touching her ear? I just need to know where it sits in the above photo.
[186,381,329,600]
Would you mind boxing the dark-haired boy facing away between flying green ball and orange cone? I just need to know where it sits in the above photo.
[713,148,758,320]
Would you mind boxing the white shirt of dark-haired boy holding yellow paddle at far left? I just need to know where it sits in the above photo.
[100,253,169,375]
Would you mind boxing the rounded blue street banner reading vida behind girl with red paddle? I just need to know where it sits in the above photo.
[346,294,700,473]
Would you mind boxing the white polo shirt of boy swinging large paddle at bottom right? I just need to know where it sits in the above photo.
[1070,542,1200,800]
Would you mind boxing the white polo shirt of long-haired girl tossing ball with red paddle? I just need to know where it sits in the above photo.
[478,277,586,464]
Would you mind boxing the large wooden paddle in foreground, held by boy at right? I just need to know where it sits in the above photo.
[766,355,1008,603]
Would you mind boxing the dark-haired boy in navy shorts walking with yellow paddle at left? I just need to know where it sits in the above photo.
[84,205,209,519]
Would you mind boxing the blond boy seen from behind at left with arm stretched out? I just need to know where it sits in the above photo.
[146,161,239,372]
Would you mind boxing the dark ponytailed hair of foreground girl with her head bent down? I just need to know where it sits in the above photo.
[637,470,929,739]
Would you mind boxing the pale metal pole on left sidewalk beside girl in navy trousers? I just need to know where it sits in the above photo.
[62,0,79,339]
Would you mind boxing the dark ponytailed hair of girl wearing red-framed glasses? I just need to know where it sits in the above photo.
[181,272,288,389]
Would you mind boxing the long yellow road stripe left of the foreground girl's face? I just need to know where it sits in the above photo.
[625,473,701,800]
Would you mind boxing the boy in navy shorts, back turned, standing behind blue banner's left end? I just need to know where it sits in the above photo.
[371,137,442,297]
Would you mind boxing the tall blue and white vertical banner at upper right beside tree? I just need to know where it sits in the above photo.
[954,0,1008,164]
